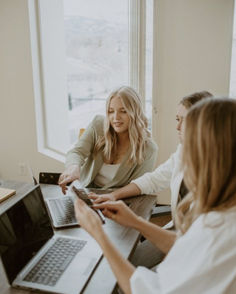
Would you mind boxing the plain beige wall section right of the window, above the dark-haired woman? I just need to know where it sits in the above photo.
[154,0,234,203]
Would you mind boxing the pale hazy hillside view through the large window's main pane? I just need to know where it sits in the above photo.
[64,0,129,142]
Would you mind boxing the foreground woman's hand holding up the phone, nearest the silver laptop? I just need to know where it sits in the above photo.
[75,199,103,241]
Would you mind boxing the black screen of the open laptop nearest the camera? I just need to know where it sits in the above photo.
[0,186,53,283]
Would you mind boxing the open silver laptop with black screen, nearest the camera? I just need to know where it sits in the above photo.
[0,185,102,294]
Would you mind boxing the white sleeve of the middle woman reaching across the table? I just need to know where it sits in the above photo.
[131,149,179,194]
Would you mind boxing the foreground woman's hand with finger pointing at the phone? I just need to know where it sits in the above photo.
[93,200,139,228]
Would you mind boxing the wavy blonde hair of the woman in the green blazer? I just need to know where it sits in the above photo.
[94,86,150,164]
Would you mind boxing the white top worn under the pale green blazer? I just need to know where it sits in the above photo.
[94,163,120,187]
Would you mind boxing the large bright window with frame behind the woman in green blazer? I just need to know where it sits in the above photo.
[29,0,153,161]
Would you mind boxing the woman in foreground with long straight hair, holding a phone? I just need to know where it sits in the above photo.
[75,98,236,294]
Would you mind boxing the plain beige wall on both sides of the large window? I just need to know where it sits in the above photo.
[0,0,233,188]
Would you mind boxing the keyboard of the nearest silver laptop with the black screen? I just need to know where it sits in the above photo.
[24,238,87,286]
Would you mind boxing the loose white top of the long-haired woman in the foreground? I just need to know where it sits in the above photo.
[131,209,236,294]
